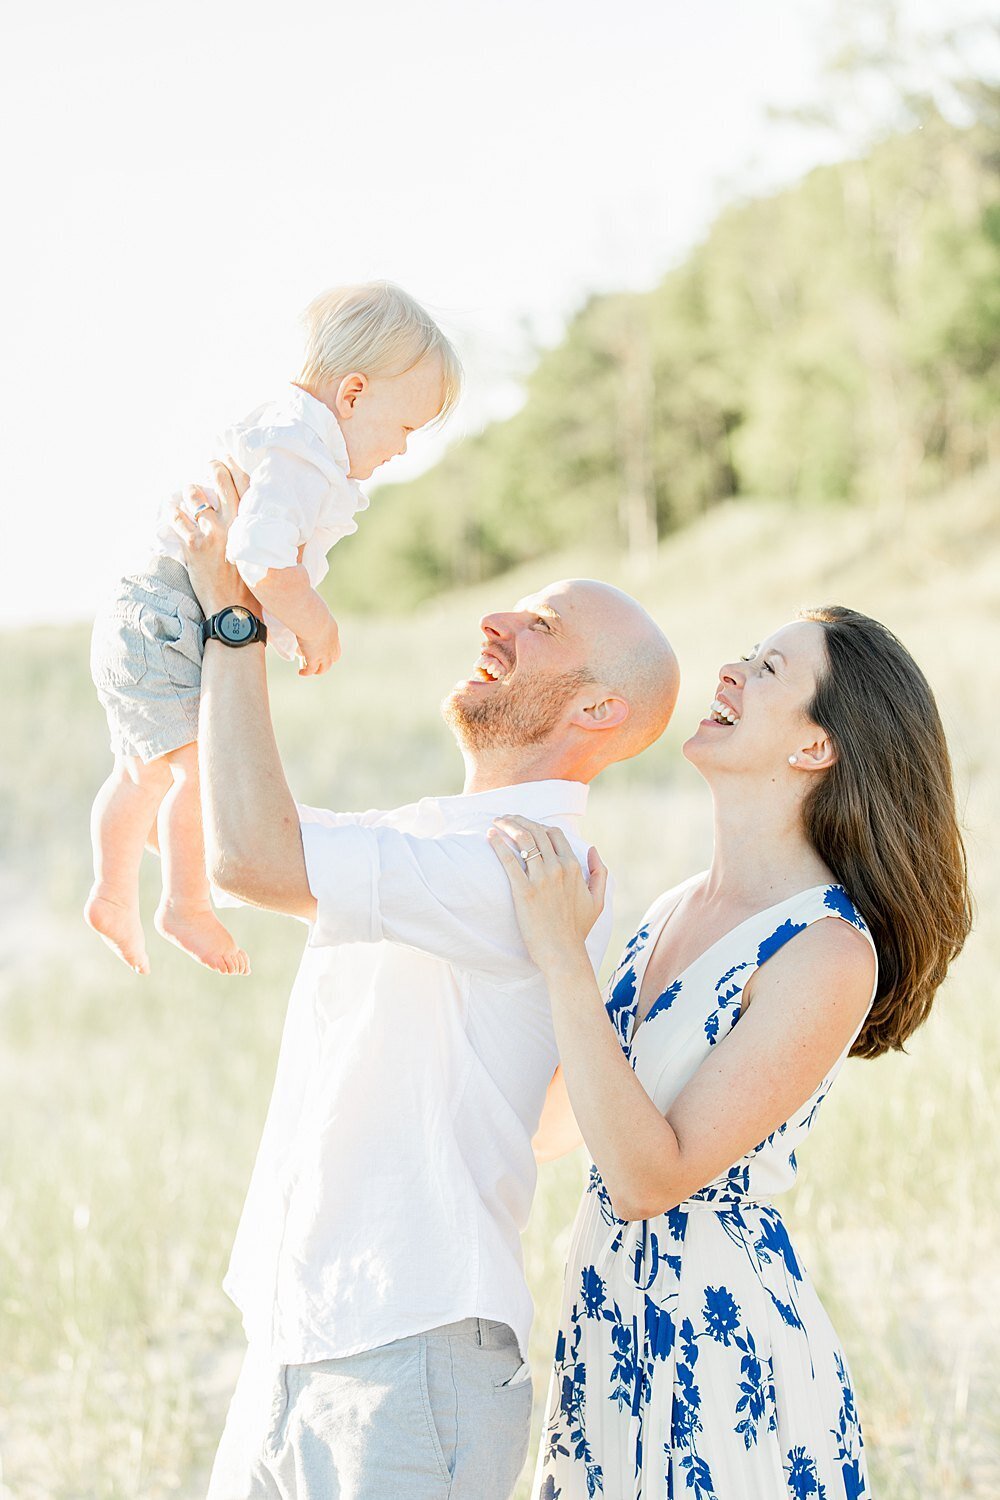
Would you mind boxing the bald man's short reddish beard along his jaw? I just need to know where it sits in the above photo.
[441,672,591,750]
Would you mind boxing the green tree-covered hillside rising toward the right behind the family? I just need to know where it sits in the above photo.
[328,102,1000,611]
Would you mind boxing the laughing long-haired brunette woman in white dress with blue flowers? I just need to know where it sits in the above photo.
[493,608,970,1500]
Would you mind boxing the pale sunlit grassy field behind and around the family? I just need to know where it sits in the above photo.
[0,477,1000,1500]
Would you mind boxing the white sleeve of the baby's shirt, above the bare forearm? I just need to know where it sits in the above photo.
[226,446,330,588]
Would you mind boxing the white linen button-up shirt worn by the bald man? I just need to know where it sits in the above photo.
[225,780,610,1364]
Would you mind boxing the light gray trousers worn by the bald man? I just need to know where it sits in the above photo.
[207,1317,531,1500]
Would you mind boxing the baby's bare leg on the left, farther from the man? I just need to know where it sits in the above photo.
[84,756,171,974]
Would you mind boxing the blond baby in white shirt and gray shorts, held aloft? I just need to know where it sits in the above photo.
[84,282,462,974]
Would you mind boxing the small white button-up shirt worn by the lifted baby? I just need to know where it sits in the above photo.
[156,386,367,660]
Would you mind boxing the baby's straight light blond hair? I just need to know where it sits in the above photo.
[297,281,462,422]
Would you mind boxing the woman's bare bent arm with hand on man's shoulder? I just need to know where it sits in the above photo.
[493,818,874,1220]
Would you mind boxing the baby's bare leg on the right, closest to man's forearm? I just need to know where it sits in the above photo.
[156,744,250,974]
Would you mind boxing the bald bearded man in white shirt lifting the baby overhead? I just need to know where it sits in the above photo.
[177,467,678,1500]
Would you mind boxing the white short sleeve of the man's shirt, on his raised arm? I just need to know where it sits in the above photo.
[301,824,607,980]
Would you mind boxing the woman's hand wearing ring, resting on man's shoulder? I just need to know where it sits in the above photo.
[489,816,607,974]
